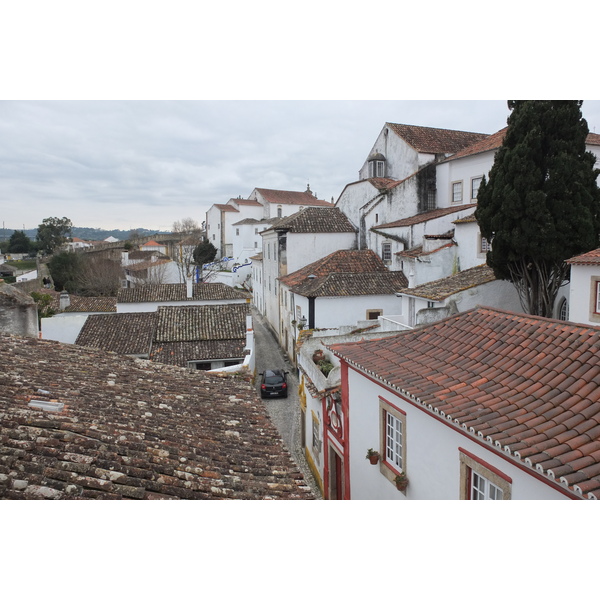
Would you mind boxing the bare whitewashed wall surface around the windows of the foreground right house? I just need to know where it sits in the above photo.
[346,369,566,500]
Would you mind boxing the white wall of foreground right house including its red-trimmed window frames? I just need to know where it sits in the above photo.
[342,368,566,500]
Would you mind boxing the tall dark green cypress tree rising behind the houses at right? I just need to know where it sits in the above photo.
[475,100,600,317]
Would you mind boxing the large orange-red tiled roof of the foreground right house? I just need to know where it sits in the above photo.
[331,307,600,498]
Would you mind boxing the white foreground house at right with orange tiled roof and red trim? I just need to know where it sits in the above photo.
[322,307,600,500]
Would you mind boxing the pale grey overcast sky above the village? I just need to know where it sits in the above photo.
[0,100,600,230]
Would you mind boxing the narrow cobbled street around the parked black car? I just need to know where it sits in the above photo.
[252,309,321,499]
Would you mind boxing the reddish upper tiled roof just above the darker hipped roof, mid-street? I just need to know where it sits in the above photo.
[279,250,388,287]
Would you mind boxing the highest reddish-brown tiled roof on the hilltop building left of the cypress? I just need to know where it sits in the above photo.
[386,123,488,154]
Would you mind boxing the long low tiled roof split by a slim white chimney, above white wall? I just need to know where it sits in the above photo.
[117,283,251,303]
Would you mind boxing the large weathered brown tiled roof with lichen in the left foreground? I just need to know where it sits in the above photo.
[0,336,312,500]
